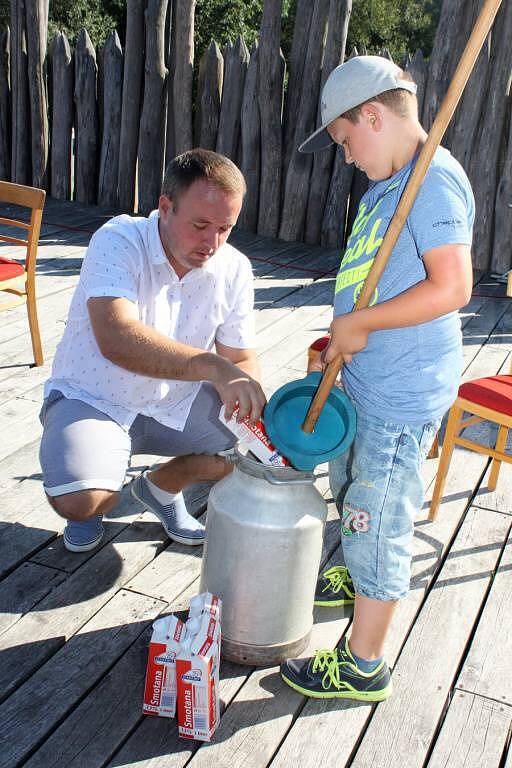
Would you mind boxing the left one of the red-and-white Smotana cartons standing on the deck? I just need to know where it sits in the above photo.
[142,616,185,717]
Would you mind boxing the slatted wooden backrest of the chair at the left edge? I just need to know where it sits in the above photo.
[0,181,46,275]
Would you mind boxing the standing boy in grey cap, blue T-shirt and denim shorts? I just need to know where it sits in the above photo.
[281,56,474,701]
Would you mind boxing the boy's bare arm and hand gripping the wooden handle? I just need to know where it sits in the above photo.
[324,245,473,363]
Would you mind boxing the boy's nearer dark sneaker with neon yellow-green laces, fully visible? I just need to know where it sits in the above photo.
[281,638,392,703]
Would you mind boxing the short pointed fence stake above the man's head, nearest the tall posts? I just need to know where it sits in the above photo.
[195,40,224,150]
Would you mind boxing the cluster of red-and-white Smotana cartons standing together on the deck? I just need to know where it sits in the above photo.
[143,592,221,741]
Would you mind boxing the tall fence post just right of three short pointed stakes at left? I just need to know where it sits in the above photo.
[117,0,144,211]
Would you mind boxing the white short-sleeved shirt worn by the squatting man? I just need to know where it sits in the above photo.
[45,211,255,430]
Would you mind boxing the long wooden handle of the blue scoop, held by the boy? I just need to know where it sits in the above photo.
[302,0,501,433]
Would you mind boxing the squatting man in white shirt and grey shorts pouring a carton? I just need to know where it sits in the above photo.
[40,150,265,552]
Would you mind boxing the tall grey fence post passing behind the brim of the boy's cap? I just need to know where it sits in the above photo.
[304,0,352,243]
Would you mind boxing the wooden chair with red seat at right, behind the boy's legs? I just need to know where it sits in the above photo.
[429,367,512,520]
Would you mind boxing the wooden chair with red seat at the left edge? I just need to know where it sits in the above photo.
[0,181,46,365]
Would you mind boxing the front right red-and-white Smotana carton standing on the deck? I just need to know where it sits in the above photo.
[176,598,220,741]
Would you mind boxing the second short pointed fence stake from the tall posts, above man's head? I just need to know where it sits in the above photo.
[216,35,249,163]
